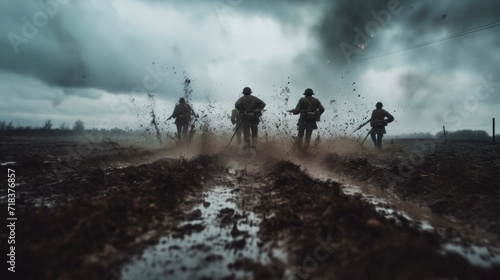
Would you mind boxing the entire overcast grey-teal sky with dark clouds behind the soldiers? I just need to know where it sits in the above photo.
[0,0,500,134]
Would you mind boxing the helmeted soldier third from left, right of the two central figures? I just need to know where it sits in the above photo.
[287,88,325,150]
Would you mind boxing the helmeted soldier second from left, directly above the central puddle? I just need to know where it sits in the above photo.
[234,87,266,149]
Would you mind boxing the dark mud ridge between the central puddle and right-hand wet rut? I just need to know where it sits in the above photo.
[261,162,500,279]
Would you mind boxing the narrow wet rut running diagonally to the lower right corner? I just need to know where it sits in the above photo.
[302,167,500,268]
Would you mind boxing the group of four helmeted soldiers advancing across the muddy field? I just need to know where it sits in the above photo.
[168,87,394,150]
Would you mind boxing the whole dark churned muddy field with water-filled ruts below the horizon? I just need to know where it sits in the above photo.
[0,132,500,280]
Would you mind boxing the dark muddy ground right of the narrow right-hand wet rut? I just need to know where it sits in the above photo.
[324,141,500,240]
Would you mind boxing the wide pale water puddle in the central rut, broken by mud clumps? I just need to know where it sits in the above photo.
[121,186,284,280]
